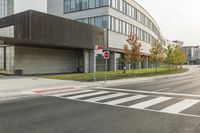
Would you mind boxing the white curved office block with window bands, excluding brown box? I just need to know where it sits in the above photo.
[47,0,165,70]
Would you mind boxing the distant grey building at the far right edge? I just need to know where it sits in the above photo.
[183,46,200,65]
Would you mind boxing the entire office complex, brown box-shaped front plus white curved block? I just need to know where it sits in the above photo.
[0,0,165,74]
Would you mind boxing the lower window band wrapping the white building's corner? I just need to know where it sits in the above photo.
[77,16,155,44]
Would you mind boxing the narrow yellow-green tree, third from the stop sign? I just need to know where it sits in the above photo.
[165,44,174,70]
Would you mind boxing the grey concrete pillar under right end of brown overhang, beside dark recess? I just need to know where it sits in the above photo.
[83,50,90,73]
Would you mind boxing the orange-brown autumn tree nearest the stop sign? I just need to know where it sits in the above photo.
[124,33,142,74]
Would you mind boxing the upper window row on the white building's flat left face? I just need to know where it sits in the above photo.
[64,0,108,13]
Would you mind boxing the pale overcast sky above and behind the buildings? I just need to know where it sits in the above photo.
[15,0,200,45]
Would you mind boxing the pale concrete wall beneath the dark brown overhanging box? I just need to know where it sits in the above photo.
[14,47,77,74]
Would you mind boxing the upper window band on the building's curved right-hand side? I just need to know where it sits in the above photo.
[109,0,159,36]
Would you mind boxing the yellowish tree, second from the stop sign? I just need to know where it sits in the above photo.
[149,40,165,72]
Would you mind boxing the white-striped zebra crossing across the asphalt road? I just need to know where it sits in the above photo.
[52,89,200,117]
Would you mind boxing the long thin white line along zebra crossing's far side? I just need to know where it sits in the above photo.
[95,87,200,98]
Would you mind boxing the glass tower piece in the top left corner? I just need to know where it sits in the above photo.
[0,0,14,18]
